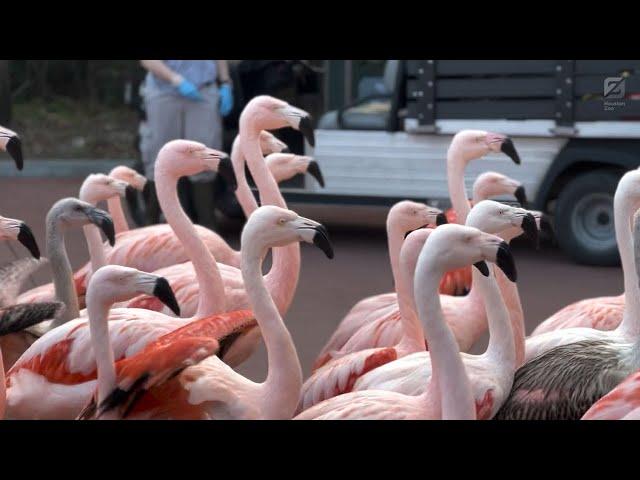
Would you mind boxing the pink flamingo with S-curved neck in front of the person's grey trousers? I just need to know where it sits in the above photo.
[7,144,255,418]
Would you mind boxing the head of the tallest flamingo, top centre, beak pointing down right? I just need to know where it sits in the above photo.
[240,95,315,147]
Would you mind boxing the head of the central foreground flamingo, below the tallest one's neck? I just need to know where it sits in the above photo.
[240,205,333,258]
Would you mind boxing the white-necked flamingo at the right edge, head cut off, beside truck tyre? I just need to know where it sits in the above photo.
[526,170,640,361]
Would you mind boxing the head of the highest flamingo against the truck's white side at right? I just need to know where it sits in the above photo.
[449,130,520,165]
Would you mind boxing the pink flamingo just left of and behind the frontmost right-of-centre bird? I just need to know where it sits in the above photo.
[313,200,446,370]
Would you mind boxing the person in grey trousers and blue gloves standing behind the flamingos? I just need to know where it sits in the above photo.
[140,60,233,228]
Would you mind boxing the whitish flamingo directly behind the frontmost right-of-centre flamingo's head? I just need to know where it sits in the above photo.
[307,200,537,419]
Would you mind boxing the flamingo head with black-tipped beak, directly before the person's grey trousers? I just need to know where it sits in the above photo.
[155,140,238,190]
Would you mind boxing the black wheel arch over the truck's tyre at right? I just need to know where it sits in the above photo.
[534,139,640,211]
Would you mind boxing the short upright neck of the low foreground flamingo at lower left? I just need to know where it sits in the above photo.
[87,293,116,405]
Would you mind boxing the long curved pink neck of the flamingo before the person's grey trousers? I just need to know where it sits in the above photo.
[155,162,227,318]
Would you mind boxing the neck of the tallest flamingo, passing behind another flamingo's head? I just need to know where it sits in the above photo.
[240,132,300,314]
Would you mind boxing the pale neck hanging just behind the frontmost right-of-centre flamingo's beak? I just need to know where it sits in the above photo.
[471,265,516,371]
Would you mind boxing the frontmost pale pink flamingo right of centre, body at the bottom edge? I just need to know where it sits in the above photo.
[295,224,515,420]
